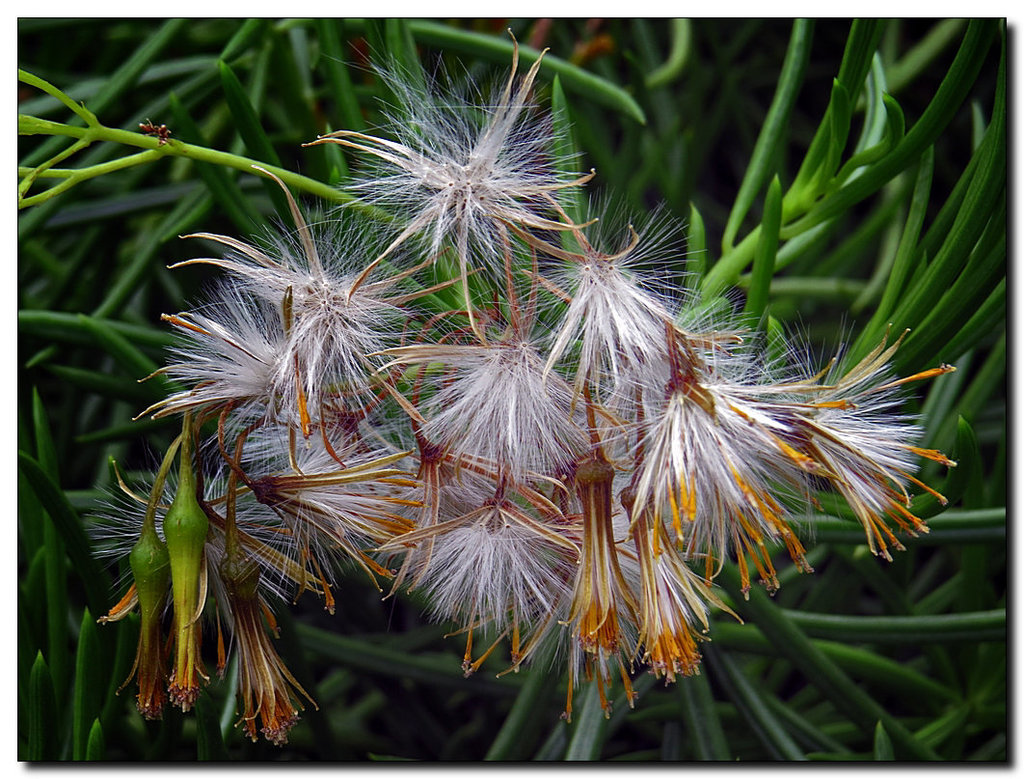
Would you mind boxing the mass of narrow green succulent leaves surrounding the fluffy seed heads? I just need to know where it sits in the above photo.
[17,19,1007,761]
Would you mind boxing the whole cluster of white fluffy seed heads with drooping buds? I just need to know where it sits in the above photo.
[96,33,953,744]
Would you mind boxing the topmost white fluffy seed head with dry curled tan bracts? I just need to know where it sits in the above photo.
[332,46,575,270]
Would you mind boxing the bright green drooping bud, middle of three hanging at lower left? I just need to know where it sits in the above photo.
[164,415,210,711]
